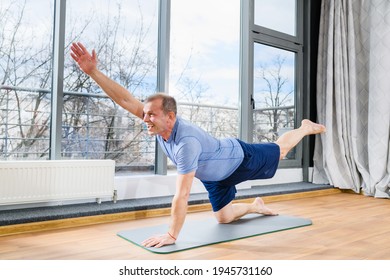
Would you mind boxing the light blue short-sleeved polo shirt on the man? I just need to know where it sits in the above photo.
[157,117,244,181]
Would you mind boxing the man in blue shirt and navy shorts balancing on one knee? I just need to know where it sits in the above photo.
[71,43,325,247]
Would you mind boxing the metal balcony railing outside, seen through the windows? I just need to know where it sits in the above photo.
[0,86,294,171]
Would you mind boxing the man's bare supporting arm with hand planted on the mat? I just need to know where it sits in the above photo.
[142,171,195,248]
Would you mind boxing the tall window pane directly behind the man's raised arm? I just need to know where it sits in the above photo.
[61,0,158,174]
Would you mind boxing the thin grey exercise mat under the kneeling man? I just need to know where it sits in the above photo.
[118,214,312,254]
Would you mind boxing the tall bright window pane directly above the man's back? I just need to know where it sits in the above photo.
[169,0,240,171]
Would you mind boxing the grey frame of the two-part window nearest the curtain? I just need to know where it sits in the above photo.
[239,0,307,168]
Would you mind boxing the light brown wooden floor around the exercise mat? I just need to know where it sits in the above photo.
[0,193,390,260]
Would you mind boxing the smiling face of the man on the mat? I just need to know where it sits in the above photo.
[144,99,171,139]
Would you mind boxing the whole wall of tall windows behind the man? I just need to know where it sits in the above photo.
[0,0,303,174]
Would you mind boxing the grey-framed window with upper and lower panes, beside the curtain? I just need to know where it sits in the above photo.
[241,0,303,167]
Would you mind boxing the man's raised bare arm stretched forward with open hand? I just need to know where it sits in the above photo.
[71,43,144,119]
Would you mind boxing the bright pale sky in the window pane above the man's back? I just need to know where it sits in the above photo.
[171,0,240,105]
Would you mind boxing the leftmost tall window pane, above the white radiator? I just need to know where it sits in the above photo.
[0,0,53,160]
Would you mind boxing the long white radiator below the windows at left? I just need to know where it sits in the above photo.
[0,160,115,205]
